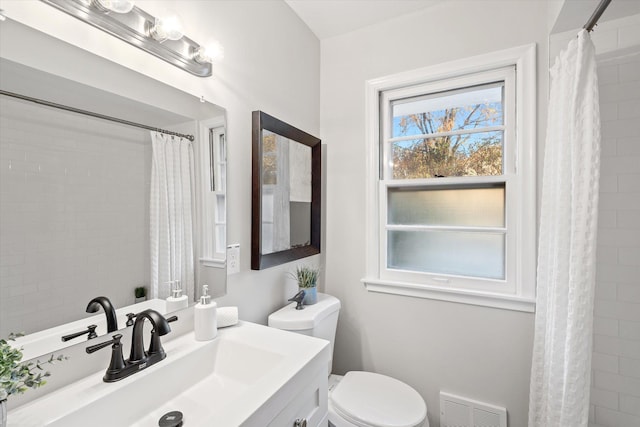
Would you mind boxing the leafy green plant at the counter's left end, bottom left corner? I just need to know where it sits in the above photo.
[0,333,68,400]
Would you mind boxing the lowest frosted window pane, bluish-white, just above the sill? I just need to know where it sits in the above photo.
[387,230,505,279]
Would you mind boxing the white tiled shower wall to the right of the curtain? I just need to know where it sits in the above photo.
[589,48,640,427]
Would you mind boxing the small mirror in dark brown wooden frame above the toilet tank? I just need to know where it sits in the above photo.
[251,111,322,270]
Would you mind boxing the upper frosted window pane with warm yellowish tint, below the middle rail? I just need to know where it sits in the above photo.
[387,184,505,227]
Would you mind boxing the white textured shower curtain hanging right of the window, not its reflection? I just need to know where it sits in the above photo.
[529,30,600,427]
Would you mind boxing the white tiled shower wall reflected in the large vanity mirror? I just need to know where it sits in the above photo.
[0,96,151,336]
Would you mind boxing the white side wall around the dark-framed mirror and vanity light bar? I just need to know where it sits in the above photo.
[0,0,320,323]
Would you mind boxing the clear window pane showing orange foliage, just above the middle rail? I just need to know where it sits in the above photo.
[391,131,504,179]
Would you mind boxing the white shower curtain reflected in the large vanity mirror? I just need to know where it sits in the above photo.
[149,132,194,298]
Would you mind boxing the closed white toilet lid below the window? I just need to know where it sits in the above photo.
[330,371,427,427]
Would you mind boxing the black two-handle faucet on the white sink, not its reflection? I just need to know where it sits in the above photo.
[87,309,177,383]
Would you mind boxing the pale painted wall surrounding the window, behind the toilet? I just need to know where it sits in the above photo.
[321,1,548,426]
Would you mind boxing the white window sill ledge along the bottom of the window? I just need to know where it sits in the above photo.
[361,278,536,313]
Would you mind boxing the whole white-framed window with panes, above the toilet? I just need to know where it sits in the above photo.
[363,47,536,311]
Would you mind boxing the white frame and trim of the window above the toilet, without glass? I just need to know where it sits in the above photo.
[362,44,536,312]
